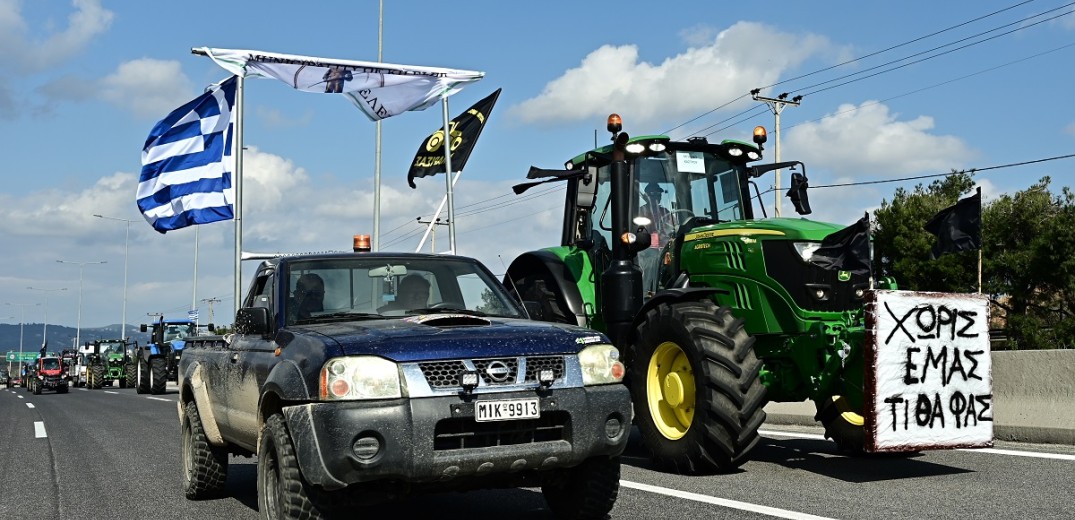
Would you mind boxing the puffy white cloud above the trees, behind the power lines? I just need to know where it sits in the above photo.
[782,101,975,179]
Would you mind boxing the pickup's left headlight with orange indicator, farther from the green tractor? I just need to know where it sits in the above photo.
[320,356,403,401]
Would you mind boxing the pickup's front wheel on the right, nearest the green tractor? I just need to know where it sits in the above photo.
[541,457,619,519]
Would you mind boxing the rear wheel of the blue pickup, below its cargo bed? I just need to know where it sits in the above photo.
[183,401,228,500]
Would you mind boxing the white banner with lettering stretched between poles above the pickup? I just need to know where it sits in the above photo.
[195,47,485,121]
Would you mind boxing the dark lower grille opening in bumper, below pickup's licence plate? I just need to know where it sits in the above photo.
[433,411,571,451]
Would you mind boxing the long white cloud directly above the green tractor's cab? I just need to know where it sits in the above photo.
[511,21,830,124]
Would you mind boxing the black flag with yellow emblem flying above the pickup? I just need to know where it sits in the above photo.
[406,88,500,188]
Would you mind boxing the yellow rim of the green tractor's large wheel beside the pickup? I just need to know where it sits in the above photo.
[646,342,694,440]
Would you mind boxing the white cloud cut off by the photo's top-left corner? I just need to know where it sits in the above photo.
[0,0,114,72]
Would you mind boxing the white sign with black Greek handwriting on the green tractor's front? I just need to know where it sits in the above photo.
[864,290,993,451]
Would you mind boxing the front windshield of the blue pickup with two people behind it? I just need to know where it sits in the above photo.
[286,256,522,324]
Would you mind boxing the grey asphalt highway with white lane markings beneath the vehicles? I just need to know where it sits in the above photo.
[0,386,1075,520]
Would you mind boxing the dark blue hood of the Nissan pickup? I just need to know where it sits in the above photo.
[290,314,607,362]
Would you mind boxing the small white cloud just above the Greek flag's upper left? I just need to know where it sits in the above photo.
[98,58,195,119]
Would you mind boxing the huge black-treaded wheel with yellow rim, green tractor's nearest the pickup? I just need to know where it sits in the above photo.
[628,300,765,474]
